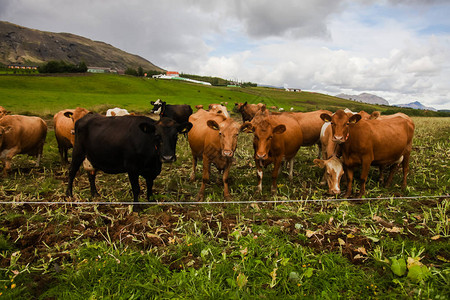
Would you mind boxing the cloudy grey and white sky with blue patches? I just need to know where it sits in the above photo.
[0,0,450,109]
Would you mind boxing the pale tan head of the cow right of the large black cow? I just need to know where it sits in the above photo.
[206,119,244,158]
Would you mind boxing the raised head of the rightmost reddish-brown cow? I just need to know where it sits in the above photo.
[320,109,361,144]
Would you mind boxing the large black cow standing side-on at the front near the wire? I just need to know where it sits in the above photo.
[66,114,192,211]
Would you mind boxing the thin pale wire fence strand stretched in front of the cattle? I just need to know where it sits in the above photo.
[0,195,450,206]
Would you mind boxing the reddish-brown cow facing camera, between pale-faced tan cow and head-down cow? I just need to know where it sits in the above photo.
[244,106,303,193]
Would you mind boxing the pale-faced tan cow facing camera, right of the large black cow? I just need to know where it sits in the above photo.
[188,112,243,201]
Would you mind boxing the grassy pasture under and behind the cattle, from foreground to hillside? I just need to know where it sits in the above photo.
[0,76,450,299]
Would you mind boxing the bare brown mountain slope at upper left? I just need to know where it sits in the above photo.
[0,21,163,71]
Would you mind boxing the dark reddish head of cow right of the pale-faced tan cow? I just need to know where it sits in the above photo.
[243,120,286,161]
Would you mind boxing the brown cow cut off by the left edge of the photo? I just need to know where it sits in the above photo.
[0,115,47,175]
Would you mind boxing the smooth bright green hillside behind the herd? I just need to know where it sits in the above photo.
[0,74,444,116]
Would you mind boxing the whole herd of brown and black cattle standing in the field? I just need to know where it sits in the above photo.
[0,99,414,210]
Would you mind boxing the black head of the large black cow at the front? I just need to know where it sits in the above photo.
[155,117,192,163]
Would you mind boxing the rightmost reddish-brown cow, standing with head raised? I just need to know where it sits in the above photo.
[321,110,414,197]
